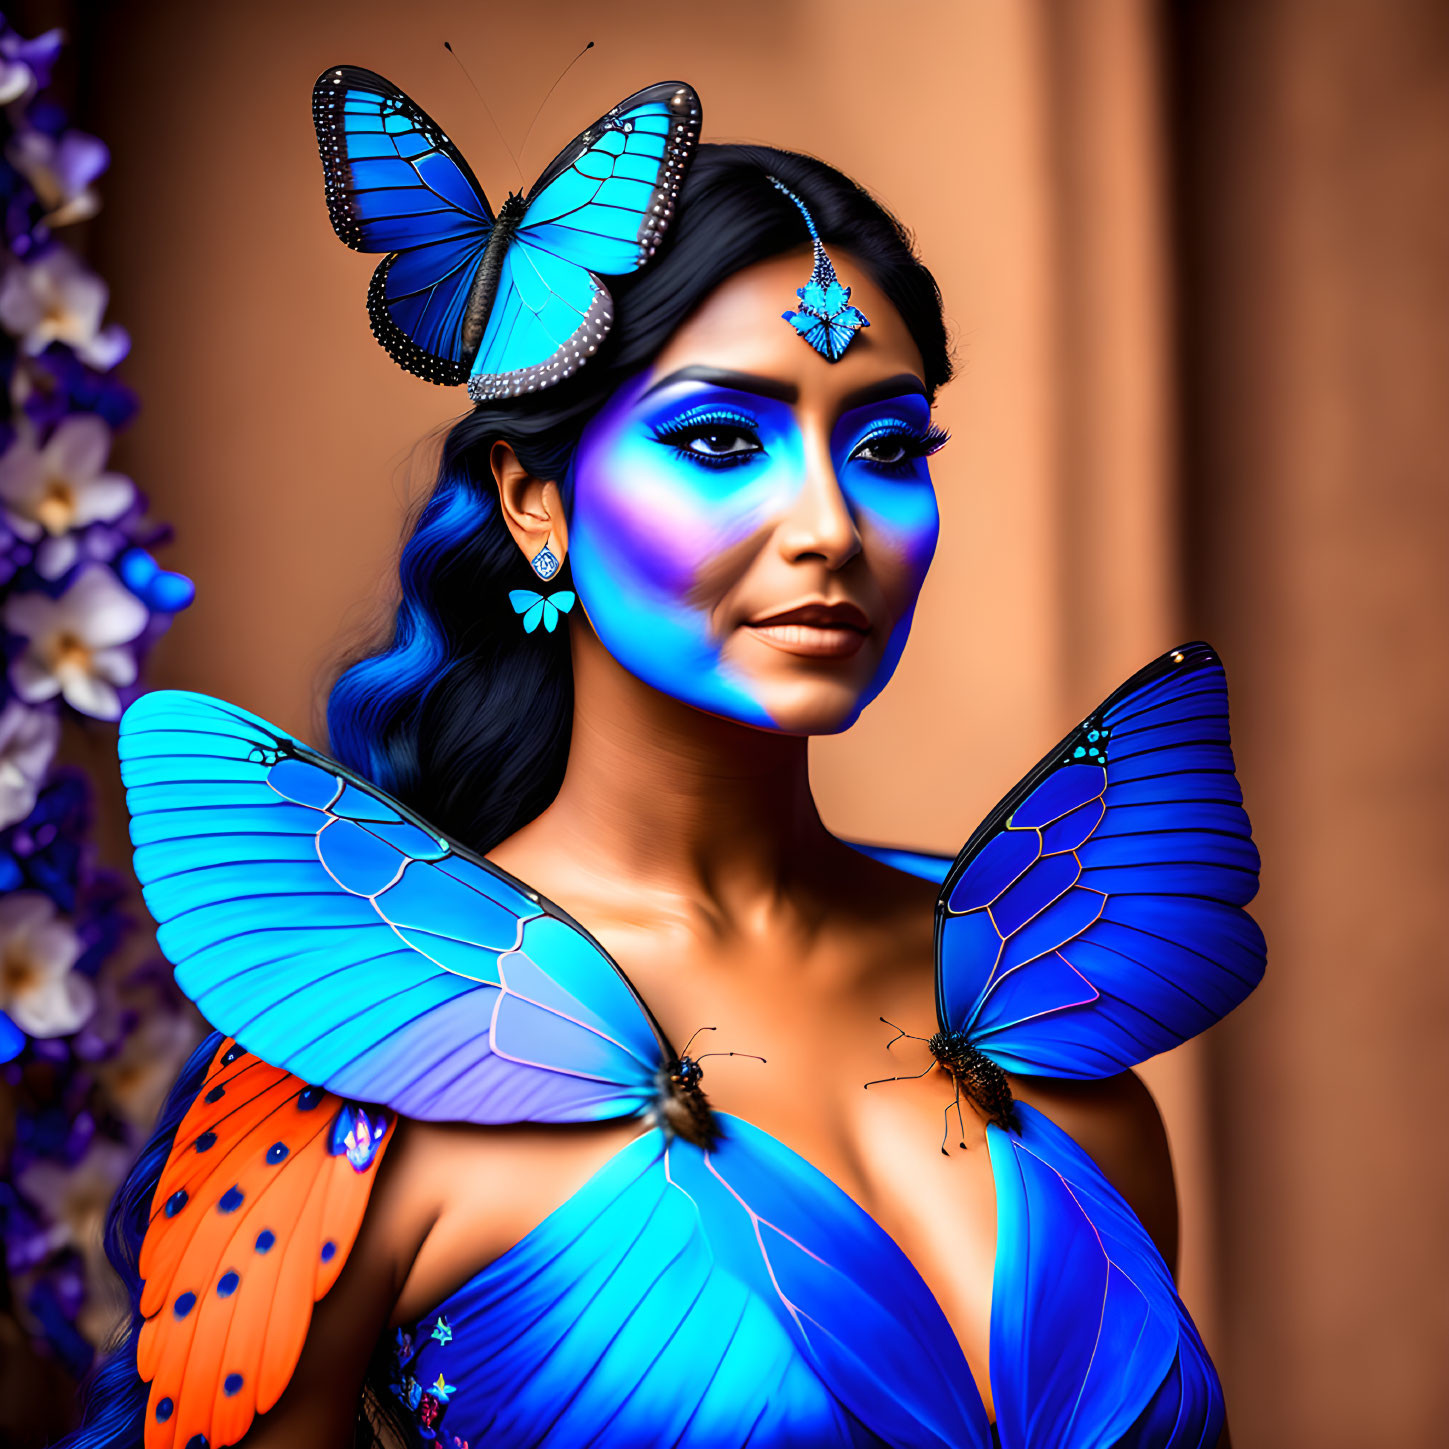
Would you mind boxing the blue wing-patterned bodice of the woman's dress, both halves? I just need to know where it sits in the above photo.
[394,1089,1222,1449]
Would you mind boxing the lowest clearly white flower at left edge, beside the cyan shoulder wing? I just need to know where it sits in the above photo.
[0,891,96,1036]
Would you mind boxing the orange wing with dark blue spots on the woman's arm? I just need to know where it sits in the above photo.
[136,1040,391,1449]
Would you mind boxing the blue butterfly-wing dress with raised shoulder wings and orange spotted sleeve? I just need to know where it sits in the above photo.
[122,645,1264,1449]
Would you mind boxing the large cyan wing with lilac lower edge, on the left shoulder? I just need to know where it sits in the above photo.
[120,691,668,1123]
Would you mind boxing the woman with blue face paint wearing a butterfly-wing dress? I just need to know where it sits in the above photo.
[62,71,1261,1449]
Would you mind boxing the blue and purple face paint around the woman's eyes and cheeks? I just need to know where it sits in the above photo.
[568,369,945,729]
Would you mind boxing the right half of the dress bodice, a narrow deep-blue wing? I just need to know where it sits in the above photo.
[987,1103,1223,1449]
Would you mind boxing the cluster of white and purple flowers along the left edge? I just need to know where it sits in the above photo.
[0,16,196,1372]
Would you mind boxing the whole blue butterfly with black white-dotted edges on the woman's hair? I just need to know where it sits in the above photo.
[312,65,700,401]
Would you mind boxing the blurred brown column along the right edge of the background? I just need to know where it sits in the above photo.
[1175,0,1449,1449]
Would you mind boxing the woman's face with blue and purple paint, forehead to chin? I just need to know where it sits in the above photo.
[568,249,943,735]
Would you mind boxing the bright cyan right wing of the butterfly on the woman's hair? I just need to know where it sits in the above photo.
[468,81,700,400]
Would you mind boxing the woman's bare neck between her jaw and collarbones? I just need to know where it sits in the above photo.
[494,627,838,909]
